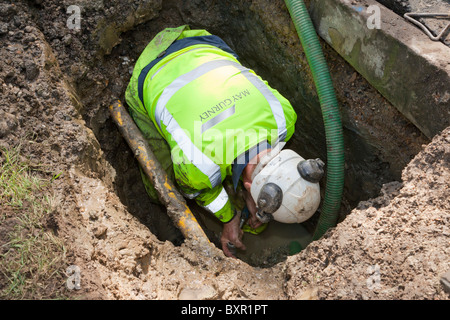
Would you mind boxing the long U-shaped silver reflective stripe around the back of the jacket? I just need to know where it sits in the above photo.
[155,60,287,187]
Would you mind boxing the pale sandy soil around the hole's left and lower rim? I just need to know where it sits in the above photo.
[0,1,450,299]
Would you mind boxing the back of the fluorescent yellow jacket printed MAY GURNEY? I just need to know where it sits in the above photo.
[144,44,296,189]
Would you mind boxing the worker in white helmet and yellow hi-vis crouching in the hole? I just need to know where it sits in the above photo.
[125,26,323,256]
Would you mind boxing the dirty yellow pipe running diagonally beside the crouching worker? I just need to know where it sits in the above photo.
[109,100,213,253]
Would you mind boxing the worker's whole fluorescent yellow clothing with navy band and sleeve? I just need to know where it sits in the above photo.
[126,26,297,223]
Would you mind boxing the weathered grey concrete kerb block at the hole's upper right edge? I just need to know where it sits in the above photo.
[309,0,450,139]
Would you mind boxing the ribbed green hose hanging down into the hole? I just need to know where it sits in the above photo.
[285,0,344,240]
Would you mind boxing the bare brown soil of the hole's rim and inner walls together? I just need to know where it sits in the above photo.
[0,0,450,299]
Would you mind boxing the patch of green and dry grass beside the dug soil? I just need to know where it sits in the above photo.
[0,146,66,299]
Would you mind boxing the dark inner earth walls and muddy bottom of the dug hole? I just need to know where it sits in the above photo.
[56,0,428,266]
